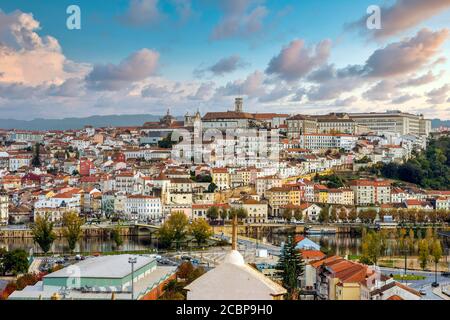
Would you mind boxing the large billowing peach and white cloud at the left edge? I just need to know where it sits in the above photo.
[0,11,89,86]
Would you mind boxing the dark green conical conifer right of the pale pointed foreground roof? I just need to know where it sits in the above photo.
[275,235,304,299]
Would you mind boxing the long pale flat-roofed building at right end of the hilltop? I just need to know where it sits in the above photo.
[349,110,431,136]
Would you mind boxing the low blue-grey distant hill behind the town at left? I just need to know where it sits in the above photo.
[0,114,172,130]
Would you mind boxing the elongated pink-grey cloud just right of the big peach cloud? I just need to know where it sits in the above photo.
[86,49,159,91]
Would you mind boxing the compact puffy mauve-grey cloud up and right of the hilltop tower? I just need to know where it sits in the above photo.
[266,39,331,81]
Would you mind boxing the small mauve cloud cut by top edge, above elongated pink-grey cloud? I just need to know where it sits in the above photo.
[119,0,164,26]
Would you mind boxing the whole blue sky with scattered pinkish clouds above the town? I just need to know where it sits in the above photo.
[0,0,450,120]
